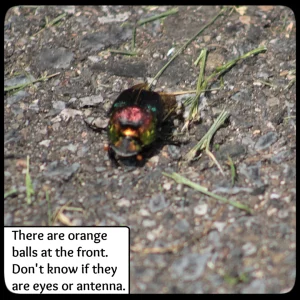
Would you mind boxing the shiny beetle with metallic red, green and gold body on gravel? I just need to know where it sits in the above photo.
[106,83,176,160]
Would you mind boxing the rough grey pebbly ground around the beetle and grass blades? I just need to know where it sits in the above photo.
[4,6,296,293]
